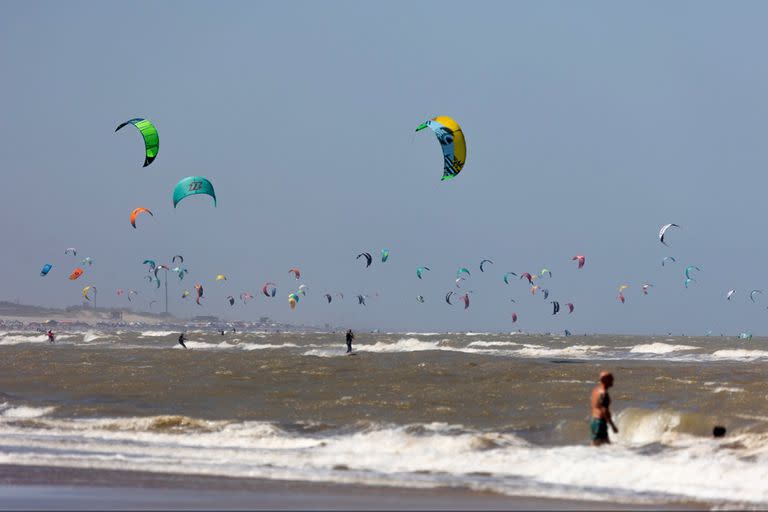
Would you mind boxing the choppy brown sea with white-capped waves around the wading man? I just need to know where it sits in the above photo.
[0,331,768,508]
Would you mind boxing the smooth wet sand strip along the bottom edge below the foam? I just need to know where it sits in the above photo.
[0,465,707,510]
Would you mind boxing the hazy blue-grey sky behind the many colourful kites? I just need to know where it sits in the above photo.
[0,1,768,334]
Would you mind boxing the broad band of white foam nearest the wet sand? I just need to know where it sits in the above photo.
[0,411,768,507]
